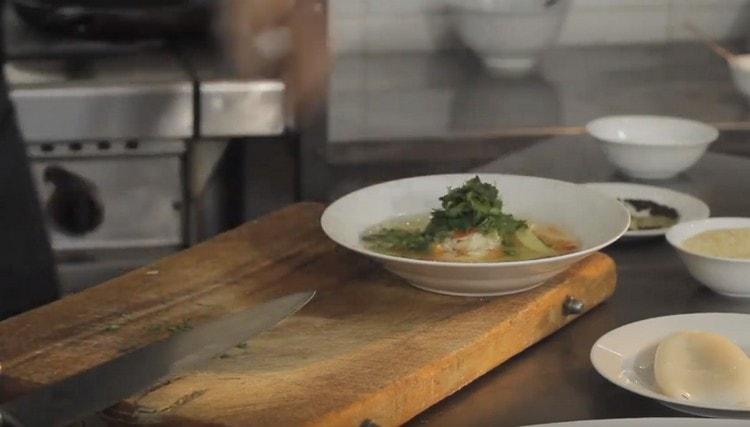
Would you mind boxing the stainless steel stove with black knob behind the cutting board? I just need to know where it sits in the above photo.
[4,5,286,292]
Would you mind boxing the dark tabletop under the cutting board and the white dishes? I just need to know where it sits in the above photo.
[411,138,750,427]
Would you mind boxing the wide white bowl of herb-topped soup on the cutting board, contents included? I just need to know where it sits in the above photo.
[321,174,630,296]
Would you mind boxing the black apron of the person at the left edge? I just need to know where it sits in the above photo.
[0,0,58,319]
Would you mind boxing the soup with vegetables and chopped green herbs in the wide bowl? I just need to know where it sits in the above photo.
[362,177,578,262]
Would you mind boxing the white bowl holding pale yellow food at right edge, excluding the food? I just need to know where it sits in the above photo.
[667,218,750,298]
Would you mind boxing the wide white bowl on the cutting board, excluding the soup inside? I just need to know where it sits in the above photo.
[321,174,630,296]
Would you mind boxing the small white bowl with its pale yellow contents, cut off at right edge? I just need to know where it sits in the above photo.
[667,218,750,298]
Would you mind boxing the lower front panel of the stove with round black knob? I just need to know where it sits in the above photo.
[29,141,186,293]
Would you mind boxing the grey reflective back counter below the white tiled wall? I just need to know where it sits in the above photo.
[329,43,750,143]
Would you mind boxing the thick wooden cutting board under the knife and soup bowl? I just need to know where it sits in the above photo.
[0,204,616,426]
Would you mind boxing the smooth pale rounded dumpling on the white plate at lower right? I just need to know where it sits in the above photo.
[654,331,750,407]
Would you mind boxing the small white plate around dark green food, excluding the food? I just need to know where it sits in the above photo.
[586,182,711,239]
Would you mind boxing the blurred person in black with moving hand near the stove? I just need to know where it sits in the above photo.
[0,0,329,320]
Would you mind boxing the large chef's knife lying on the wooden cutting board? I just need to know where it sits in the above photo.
[0,291,315,427]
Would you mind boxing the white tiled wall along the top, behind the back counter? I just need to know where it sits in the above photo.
[329,0,750,53]
